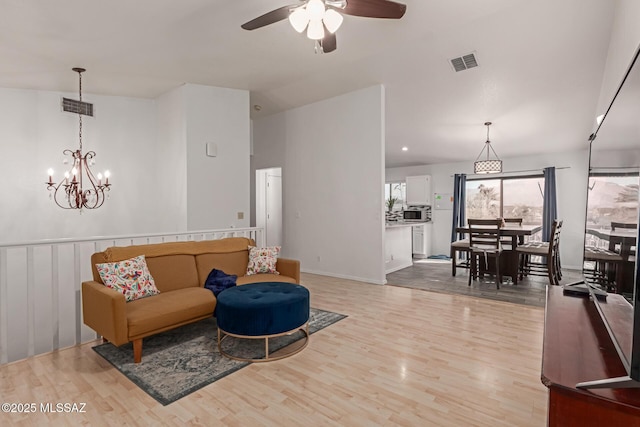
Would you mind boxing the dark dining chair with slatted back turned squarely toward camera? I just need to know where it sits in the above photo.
[468,218,502,289]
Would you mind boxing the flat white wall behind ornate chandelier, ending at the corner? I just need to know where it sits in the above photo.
[0,88,173,243]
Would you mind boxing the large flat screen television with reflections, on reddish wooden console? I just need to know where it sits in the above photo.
[565,48,640,389]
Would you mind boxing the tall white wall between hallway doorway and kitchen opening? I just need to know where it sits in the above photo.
[252,86,385,284]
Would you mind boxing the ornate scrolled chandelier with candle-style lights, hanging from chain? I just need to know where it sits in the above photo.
[46,68,111,210]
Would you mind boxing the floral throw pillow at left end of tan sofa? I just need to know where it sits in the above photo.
[96,255,160,302]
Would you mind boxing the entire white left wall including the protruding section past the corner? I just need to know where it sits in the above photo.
[0,85,250,243]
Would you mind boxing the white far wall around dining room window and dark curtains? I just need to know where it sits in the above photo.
[385,150,588,269]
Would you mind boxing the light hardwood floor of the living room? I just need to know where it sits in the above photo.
[0,274,547,427]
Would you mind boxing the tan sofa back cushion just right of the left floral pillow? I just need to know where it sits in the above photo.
[147,255,200,292]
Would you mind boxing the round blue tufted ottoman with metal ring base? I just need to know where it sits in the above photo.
[216,282,309,362]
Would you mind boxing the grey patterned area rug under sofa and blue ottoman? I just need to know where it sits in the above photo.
[93,308,347,405]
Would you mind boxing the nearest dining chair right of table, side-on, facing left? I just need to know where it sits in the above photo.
[516,219,562,285]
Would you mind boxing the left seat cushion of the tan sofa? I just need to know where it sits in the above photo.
[127,287,216,339]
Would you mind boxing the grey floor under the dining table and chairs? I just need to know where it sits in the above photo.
[387,259,582,307]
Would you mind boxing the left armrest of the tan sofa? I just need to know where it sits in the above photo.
[82,281,129,345]
